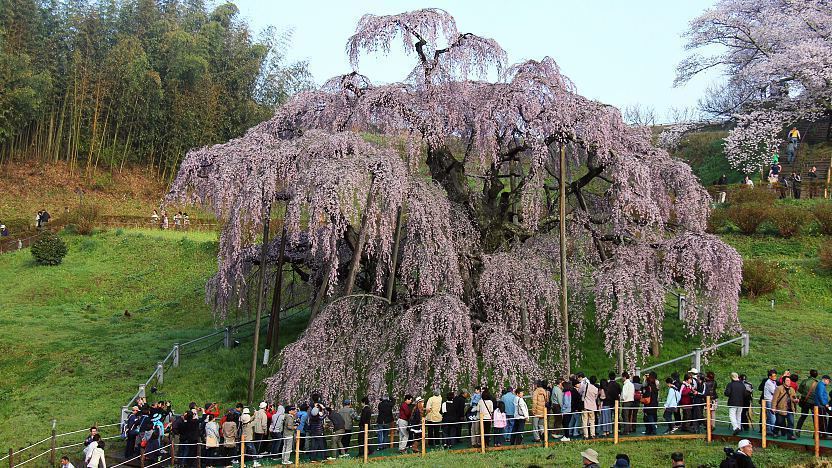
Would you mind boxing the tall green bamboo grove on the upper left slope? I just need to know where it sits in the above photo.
[0,0,311,179]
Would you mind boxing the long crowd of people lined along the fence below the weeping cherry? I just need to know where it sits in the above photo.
[58,368,832,468]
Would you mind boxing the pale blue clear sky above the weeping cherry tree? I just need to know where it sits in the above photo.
[236,0,718,121]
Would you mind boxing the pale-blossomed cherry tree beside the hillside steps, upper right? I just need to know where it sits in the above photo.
[676,0,832,173]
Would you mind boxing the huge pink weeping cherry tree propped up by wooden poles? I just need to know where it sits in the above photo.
[170,9,741,399]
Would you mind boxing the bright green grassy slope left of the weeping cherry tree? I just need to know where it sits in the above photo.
[0,230,305,451]
